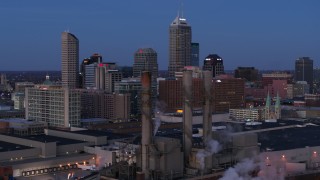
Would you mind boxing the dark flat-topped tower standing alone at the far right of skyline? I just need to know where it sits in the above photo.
[295,57,313,93]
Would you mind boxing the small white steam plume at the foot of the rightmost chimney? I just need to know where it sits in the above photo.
[196,139,222,170]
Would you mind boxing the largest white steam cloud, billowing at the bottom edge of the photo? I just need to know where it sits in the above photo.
[220,158,284,180]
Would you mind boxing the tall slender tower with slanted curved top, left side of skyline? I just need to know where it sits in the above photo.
[61,32,79,88]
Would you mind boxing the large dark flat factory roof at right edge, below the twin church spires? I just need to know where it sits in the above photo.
[258,125,320,151]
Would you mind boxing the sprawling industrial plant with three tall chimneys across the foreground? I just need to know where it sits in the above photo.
[0,71,320,179]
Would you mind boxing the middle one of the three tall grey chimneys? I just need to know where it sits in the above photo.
[182,70,193,165]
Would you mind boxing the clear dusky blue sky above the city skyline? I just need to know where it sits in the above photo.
[0,0,320,71]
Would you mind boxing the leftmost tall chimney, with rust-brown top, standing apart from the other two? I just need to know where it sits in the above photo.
[141,71,152,179]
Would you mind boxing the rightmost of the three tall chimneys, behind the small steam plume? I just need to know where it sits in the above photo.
[203,71,212,170]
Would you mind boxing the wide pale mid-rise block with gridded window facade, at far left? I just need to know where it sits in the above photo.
[25,85,80,128]
